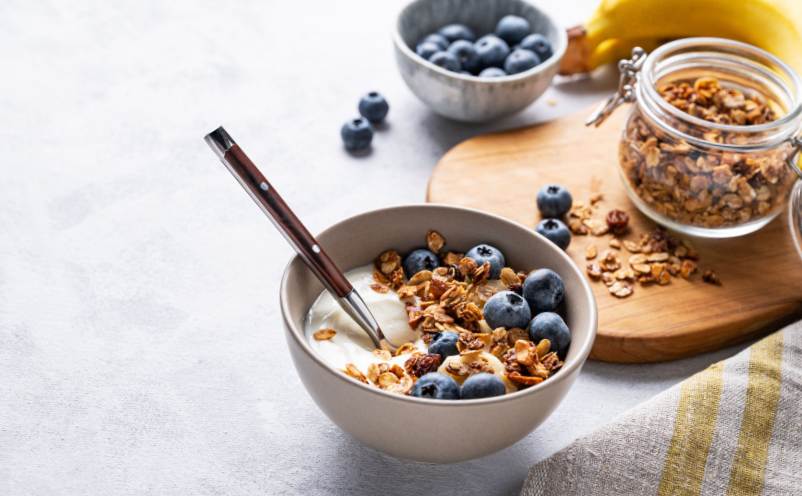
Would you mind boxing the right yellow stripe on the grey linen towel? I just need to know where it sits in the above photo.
[727,332,783,496]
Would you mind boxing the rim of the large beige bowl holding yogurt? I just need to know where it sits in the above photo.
[279,203,598,408]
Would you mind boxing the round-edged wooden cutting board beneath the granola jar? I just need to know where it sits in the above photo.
[427,105,802,363]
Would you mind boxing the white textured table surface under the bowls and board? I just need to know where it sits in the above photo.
[0,0,752,495]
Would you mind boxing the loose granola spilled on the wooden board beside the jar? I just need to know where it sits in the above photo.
[568,194,721,298]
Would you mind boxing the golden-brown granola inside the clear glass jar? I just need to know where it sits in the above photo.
[619,77,794,228]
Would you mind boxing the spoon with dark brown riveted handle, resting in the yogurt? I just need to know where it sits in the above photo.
[204,126,397,351]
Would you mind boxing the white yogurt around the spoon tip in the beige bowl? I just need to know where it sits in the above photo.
[304,265,426,372]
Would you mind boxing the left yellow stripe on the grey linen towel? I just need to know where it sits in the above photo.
[657,362,724,496]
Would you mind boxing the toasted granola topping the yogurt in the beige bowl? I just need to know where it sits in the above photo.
[334,231,563,394]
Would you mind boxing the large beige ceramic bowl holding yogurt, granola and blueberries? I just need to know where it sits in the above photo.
[280,205,596,463]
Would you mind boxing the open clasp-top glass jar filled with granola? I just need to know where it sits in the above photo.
[588,38,802,238]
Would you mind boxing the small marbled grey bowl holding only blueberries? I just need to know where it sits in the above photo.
[393,0,568,122]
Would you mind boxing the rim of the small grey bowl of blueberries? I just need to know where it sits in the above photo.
[393,0,568,85]
